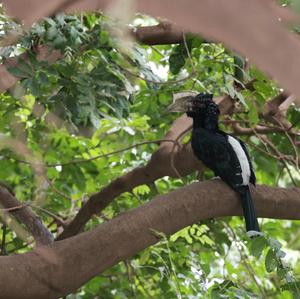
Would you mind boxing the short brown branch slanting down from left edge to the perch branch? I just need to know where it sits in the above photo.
[0,187,53,245]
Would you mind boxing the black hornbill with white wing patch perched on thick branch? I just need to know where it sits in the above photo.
[168,92,259,236]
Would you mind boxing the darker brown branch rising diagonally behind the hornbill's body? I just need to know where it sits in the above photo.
[58,92,237,240]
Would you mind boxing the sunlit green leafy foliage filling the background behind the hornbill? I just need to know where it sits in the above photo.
[0,13,300,299]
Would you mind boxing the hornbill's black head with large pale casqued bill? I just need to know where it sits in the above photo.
[167,92,220,117]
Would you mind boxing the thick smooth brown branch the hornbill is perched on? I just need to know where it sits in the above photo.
[0,180,300,299]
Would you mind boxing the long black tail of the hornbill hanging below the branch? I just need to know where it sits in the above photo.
[238,186,260,232]
